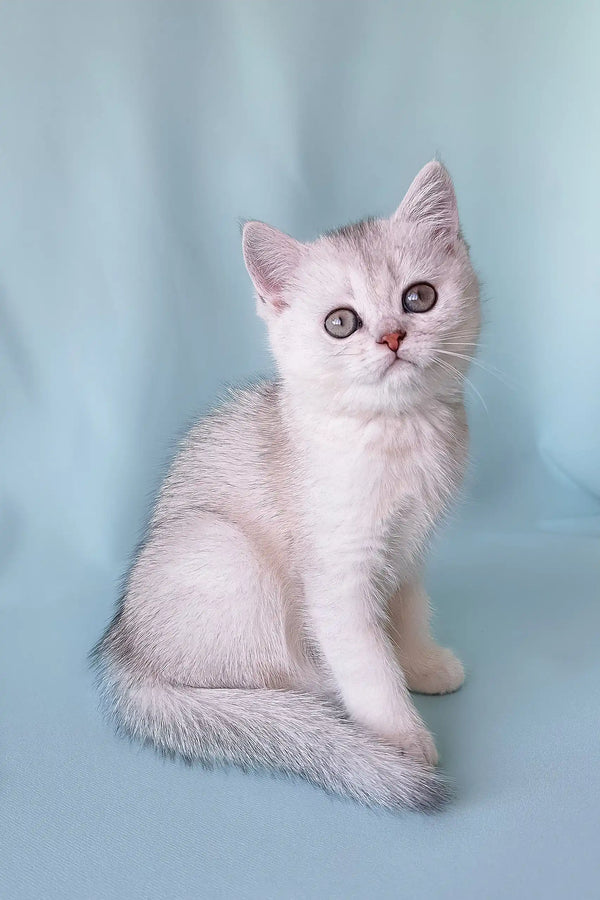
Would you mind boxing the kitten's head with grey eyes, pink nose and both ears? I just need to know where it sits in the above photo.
[243,162,479,411]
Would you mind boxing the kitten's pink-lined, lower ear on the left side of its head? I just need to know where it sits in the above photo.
[242,222,305,312]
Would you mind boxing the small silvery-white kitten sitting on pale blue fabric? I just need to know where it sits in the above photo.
[97,162,479,809]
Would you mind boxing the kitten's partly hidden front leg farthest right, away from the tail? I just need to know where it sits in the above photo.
[390,580,465,694]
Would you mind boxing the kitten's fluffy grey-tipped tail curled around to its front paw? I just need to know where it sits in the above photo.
[96,656,448,810]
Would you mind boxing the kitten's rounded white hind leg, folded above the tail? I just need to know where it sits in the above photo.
[117,510,298,688]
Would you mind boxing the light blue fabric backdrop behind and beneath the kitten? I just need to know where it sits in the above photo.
[0,0,600,900]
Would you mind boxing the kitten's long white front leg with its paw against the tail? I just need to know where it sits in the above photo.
[305,559,437,765]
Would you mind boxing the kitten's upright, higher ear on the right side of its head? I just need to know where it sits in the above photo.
[392,160,460,237]
